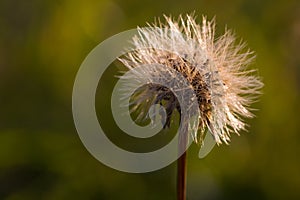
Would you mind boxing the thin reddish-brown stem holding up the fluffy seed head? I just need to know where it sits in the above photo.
[177,126,187,200]
